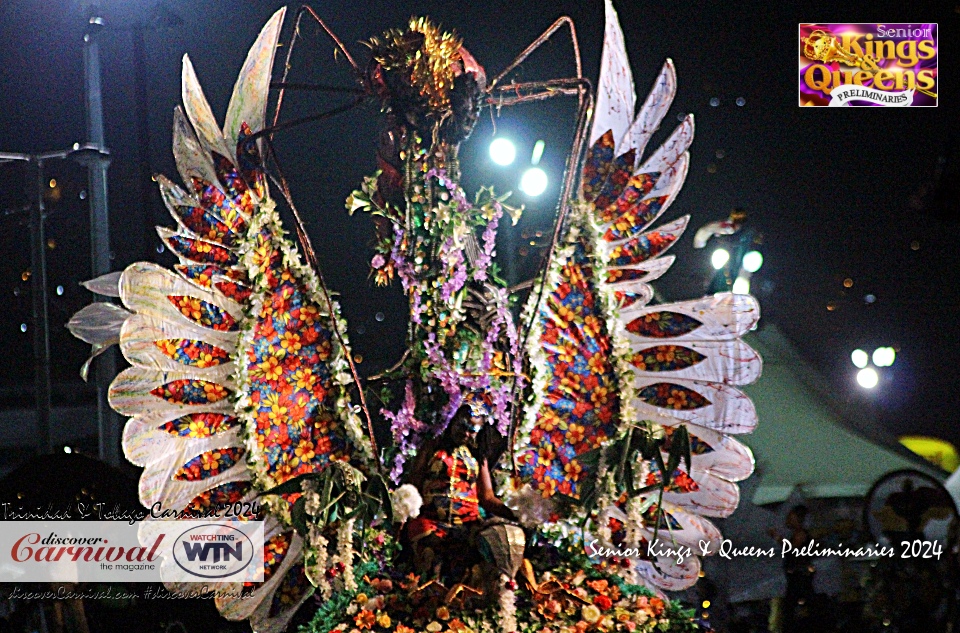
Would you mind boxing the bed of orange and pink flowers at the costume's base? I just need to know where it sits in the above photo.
[300,530,701,633]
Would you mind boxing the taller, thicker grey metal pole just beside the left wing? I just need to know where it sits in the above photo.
[83,3,120,466]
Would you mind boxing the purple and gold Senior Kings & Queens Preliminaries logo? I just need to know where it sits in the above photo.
[800,23,938,107]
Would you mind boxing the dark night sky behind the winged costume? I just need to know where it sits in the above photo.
[0,0,960,442]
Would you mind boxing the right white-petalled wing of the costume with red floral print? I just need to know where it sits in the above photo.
[516,0,761,590]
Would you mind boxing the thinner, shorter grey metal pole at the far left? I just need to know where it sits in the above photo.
[30,158,53,455]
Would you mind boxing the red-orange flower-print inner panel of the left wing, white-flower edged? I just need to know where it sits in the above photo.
[240,210,366,488]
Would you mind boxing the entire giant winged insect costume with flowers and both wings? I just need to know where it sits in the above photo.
[71,0,761,633]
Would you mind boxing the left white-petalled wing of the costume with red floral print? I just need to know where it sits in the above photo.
[66,10,371,631]
